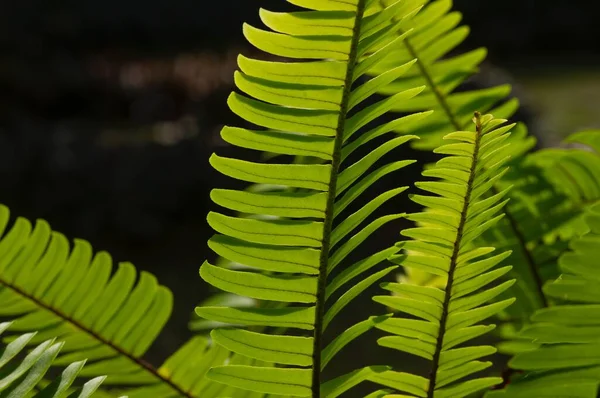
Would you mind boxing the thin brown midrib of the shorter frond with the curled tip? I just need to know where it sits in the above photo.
[427,112,482,398]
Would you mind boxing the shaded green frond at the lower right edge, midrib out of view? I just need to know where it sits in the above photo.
[490,205,600,398]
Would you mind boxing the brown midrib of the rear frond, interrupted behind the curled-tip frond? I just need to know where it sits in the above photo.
[404,32,548,307]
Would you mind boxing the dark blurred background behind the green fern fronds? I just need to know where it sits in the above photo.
[0,0,600,392]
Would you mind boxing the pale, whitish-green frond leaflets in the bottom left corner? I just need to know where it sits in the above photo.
[0,322,106,398]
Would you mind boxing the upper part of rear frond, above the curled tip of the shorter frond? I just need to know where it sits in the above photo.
[373,0,518,150]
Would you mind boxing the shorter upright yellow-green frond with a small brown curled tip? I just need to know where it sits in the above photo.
[373,114,514,398]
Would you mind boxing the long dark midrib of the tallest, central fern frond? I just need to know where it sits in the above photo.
[311,0,367,398]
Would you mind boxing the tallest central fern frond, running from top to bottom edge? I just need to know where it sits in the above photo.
[192,0,429,397]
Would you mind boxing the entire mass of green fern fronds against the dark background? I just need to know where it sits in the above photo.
[0,0,600,398]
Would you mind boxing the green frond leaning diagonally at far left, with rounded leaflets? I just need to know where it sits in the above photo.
[0,206,241,398]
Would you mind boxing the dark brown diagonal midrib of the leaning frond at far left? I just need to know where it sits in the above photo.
[0,276,194,398]
